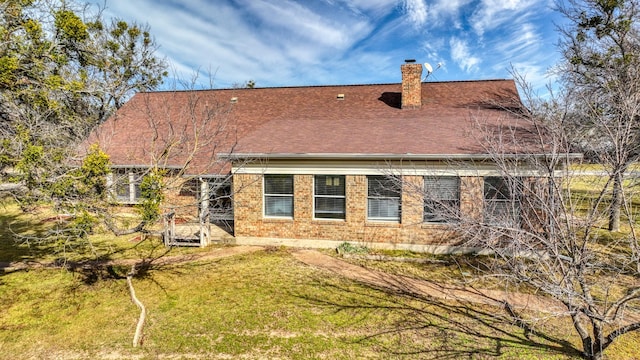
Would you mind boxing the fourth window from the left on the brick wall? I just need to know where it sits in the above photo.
[424,176,460,223]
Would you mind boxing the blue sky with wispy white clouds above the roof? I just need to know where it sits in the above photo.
[94,0,562,88]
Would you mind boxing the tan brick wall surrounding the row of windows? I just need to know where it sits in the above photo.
[233,174,483,245]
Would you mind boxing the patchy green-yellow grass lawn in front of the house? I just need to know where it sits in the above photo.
[0,201,640,359]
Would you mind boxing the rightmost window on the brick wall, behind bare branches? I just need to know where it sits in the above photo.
[484,177,520,226]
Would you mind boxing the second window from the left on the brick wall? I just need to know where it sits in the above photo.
[313,175,345,219]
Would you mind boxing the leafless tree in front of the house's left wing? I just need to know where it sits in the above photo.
[85,72,237,245]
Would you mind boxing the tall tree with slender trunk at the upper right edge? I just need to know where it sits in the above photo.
[559,0,640,231]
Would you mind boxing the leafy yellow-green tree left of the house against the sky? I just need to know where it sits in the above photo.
[0,0,166,210]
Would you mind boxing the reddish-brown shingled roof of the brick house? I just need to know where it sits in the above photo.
[88,67,525,174]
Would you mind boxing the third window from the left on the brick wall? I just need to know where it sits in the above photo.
[367,176,400,221]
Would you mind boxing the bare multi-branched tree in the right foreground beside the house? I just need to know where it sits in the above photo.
[416,79,640,359]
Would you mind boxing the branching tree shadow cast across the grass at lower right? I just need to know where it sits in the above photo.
[295,262,580,359]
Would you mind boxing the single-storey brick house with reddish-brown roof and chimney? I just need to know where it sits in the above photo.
[89,60,536,251]
